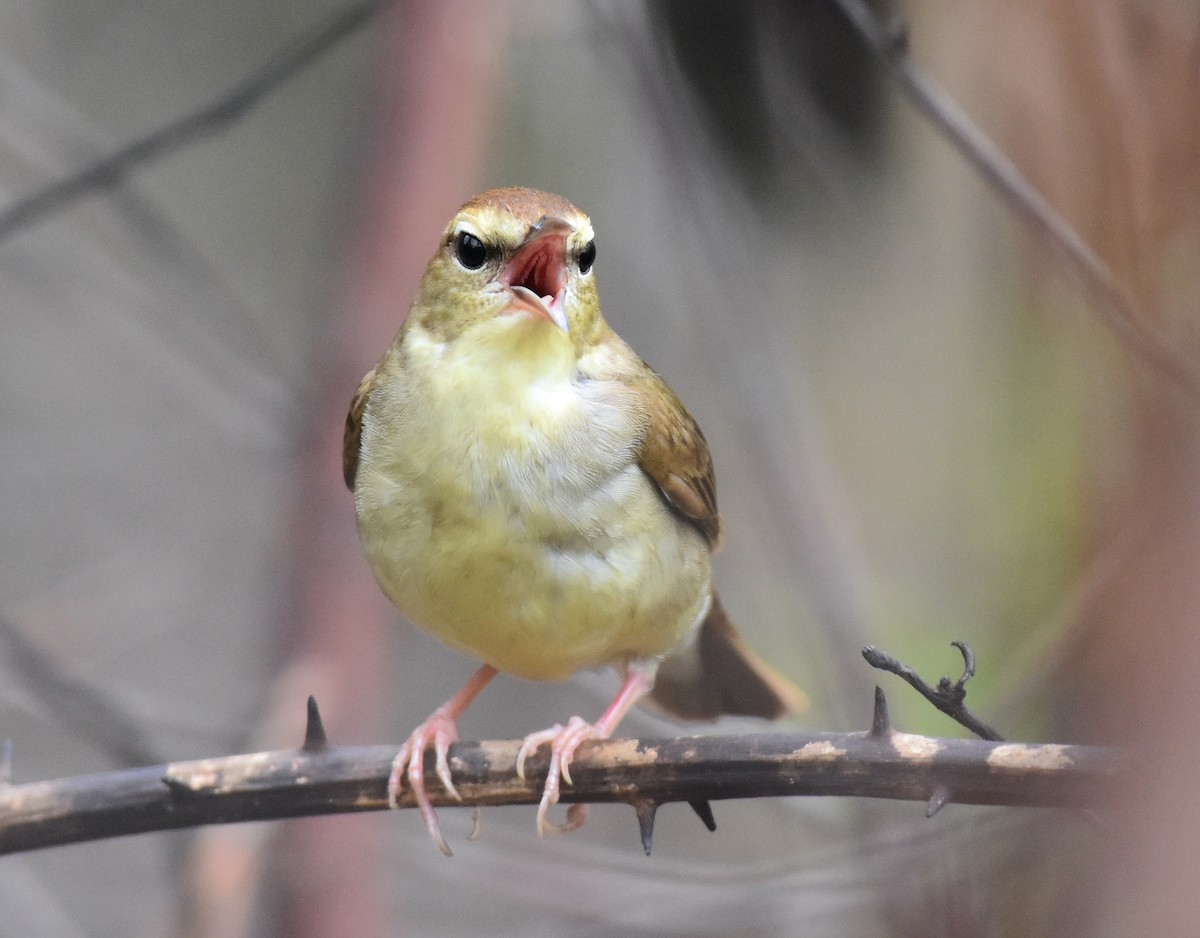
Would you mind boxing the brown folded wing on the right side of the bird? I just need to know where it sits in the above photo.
[625,361,721,551]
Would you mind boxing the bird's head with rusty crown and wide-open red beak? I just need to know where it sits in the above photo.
[412,188,604,354]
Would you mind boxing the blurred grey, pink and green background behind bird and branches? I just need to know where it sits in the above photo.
[0,0,1200,938]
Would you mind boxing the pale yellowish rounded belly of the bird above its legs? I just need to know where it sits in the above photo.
[360,467,709,680]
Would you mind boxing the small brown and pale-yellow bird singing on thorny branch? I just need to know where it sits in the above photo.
[342,187,805,855]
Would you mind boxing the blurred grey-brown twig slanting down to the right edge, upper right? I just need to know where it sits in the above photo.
[835,0,1200,397]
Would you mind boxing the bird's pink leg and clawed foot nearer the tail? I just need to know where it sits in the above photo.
[517,661,658,837]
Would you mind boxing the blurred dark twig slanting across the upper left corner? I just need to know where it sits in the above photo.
[0,0,386,240]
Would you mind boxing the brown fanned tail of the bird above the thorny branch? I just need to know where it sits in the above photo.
[650,593,809,720]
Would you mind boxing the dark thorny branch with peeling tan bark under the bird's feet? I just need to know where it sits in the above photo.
[0,691,1128,854]
